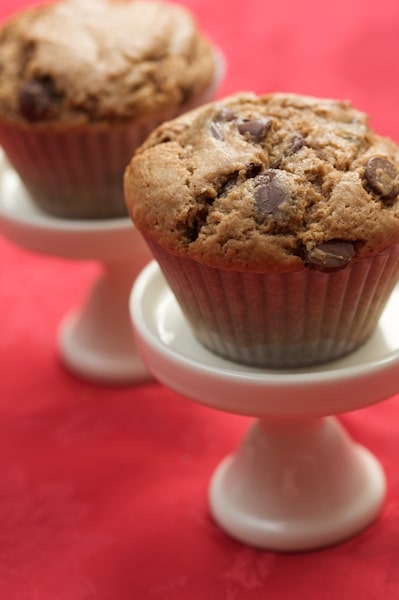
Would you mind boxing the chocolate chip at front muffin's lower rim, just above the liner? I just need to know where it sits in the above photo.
[306,240,355,272]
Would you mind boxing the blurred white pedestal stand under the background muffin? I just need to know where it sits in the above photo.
[0,156,151,384]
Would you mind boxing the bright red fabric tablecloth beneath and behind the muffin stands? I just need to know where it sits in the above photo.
[0,0,399,600]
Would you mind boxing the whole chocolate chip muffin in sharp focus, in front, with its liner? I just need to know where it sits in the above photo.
[125,94,399,368]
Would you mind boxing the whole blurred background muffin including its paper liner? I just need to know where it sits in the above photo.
[0,0,217,218]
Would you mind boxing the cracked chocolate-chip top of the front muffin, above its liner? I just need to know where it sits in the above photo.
[125,93,399,272]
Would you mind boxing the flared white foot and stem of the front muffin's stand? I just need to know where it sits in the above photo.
[209,418,386,551]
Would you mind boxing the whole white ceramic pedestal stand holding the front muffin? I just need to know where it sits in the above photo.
[130,262,399,551]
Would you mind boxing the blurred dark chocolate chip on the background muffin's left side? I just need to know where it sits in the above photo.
[19,78,60,121]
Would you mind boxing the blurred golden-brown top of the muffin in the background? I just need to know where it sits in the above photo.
[0,0,215,125]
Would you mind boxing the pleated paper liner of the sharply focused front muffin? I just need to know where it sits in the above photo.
[148,241,399,368]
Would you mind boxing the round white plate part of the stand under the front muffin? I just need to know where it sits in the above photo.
[130,261,399,417]
